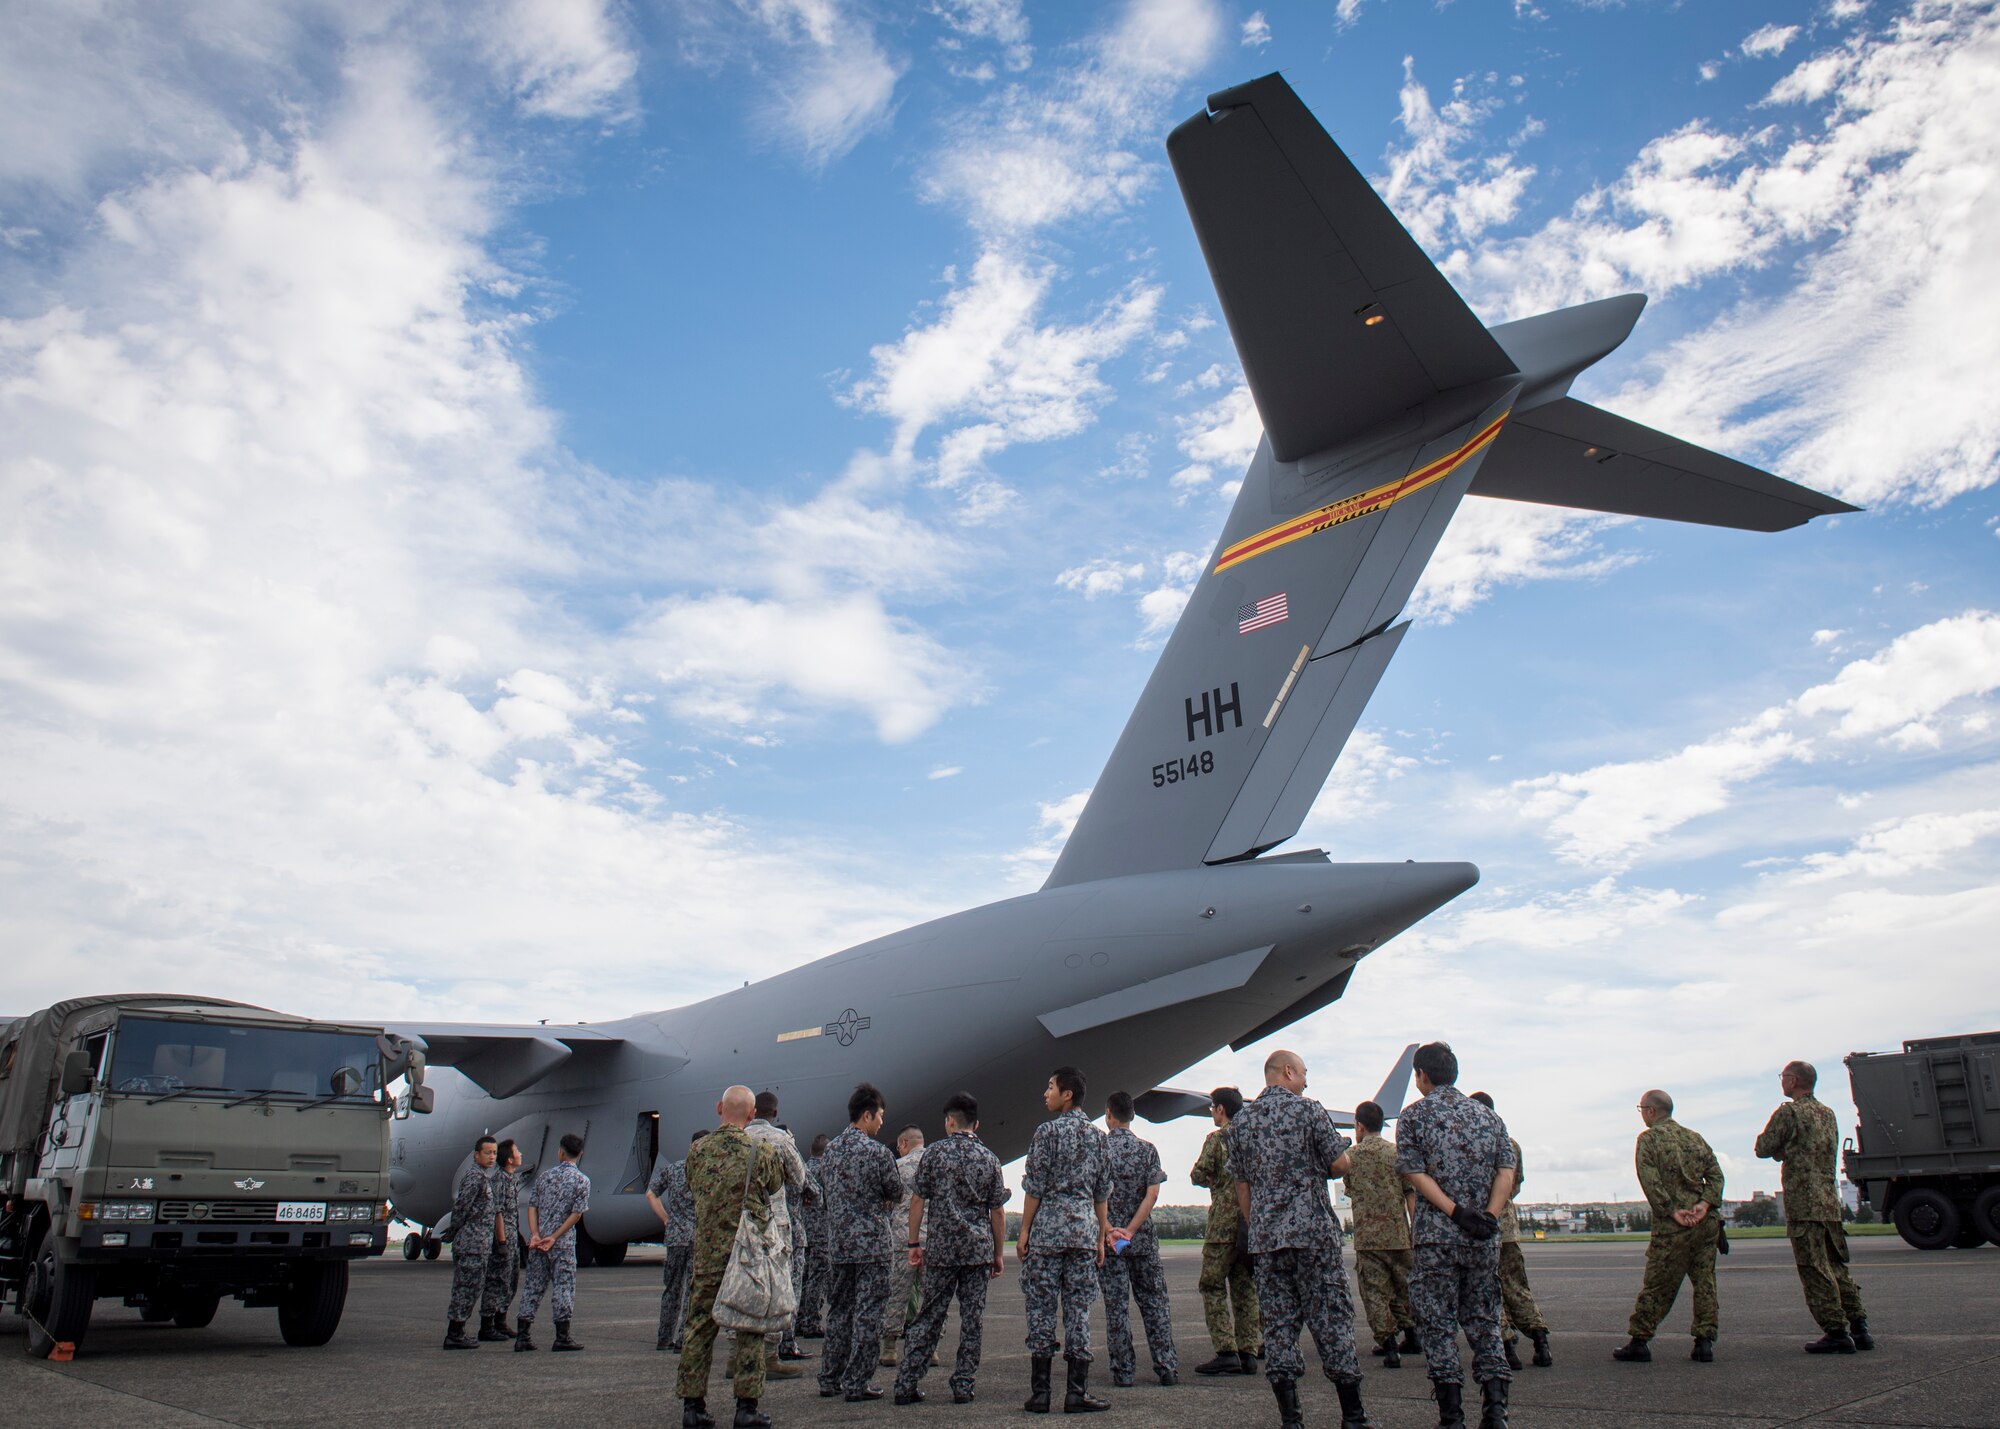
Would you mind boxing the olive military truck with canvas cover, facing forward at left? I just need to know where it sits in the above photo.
[0,995,430,1359]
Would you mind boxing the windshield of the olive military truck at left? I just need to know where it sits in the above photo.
[110,1017,380,1101]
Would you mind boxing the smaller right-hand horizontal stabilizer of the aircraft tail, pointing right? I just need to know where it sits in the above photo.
[1472,396,1856,530]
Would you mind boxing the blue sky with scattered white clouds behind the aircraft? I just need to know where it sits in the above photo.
[0,0,2000,1197]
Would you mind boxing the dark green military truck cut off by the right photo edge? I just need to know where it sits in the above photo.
[1844,1033,2000,1251]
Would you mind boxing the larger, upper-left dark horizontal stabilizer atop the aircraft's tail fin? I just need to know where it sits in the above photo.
[1166,74,1516,462]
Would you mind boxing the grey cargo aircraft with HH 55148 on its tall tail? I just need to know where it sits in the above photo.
[392,74,1854,1261]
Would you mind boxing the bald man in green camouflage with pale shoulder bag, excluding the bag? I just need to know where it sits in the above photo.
[676,1087,784,1429]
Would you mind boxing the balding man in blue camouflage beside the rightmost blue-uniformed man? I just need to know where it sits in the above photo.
[1228,1049,1370,1429]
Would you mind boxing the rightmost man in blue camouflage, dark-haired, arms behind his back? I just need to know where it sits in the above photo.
[1396,1043,1514,1429]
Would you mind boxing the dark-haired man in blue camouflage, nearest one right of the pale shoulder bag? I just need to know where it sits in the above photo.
[820,1083,902,1403]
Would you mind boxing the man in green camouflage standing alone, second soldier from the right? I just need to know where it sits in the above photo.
[1612,1091,1722,1365]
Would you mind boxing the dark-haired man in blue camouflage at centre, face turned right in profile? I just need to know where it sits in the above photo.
[1014,1067,1112,1415]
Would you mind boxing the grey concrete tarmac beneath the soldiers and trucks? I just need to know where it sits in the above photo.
[0,1237,2000,1429]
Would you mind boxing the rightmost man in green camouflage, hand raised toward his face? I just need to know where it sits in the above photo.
[1756,1063,1874,1355]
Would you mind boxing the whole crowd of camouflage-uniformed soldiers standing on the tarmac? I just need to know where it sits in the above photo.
[430,1043,1874,1429]
